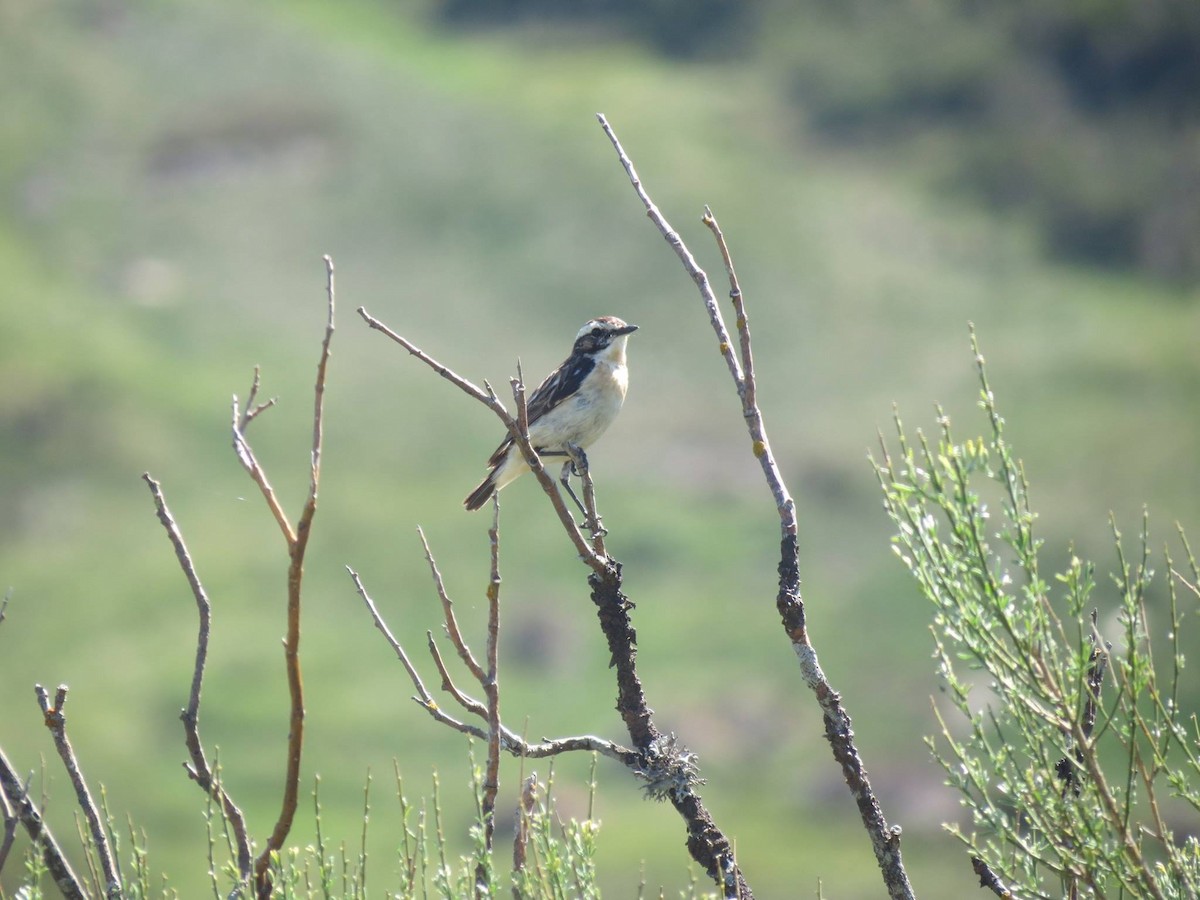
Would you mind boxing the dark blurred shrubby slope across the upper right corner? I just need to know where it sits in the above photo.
[439,0,1200,284]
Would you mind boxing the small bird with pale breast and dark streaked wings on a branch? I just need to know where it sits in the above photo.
[462,316,637,510]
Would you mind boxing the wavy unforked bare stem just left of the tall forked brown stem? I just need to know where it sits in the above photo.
[142,473,251,882]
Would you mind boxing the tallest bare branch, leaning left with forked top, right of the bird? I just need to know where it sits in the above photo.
[596,115,913,900]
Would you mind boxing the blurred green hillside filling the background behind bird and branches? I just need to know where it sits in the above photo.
[0,0,1200,898]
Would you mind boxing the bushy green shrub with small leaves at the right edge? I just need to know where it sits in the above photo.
[874,330,1200,898]
